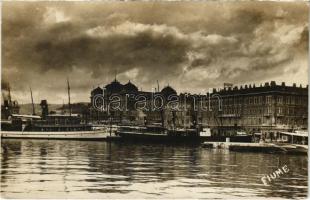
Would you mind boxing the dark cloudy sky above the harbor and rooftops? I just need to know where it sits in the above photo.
[2,2,309,103]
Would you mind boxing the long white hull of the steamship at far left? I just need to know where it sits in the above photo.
[1,130,110,140]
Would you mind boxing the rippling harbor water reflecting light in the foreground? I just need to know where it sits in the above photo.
[1,139,308,199]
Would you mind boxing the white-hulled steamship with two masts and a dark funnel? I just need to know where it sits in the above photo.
[1,81,116,140]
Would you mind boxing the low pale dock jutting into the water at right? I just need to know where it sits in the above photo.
[203,142,307,154]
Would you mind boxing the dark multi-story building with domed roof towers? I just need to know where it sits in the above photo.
[90,79,176,123]
